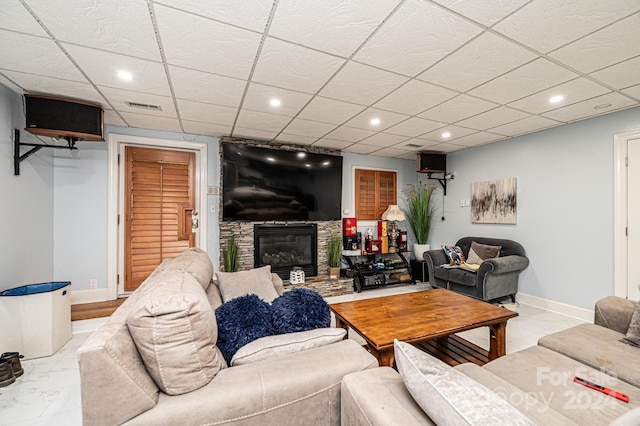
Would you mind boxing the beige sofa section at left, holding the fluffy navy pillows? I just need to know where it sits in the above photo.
[77,249,378,426]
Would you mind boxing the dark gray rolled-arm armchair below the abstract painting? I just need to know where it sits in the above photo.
[424,237,529,302]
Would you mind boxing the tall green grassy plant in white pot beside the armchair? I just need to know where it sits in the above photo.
[403,182,435,261]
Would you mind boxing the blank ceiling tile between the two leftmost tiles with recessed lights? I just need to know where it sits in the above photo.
[169,65,247,107]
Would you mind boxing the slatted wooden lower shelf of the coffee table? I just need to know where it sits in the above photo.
[414,334,489,366]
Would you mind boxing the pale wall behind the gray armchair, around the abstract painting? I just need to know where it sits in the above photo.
[432,108,640,309]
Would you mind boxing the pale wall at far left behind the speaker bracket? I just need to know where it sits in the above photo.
[0,84,54,290]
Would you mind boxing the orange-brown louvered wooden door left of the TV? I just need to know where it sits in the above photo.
[123,146,195,292]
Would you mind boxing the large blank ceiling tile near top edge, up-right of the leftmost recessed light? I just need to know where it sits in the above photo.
[155,5,261,79]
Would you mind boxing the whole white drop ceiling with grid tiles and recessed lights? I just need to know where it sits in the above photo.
[0,0,640,159]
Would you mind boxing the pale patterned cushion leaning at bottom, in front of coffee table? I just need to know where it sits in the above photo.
[394,340,534,426]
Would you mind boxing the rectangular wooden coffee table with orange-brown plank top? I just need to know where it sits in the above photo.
[330,288,518,366]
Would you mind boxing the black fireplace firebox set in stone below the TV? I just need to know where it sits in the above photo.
[253,223,318,280]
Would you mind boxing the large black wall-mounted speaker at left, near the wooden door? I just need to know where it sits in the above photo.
[24,94,104,141]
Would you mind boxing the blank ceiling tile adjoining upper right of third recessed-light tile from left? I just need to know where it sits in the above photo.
[374,80,457,115]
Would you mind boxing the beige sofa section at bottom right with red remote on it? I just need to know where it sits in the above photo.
[342,297,640,426]
